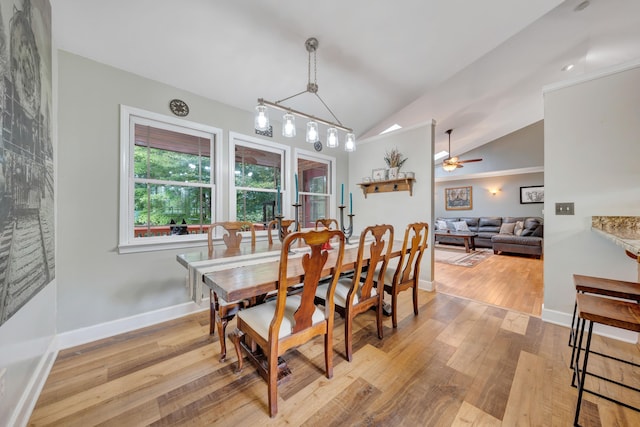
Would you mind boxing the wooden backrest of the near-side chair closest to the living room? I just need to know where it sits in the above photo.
[393,222,429,284]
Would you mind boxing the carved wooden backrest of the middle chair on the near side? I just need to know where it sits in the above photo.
[347,224,393,306]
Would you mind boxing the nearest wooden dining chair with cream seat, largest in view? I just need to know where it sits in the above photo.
[231,230,345,417]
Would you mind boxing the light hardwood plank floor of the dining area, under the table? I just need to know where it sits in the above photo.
[29,291,640,427]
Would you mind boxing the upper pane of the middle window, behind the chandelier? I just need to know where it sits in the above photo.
[234,144,282,190]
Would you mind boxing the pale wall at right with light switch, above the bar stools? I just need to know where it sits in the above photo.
[543,61,640,332]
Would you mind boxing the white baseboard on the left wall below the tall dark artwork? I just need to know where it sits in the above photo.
[9,337,58,427]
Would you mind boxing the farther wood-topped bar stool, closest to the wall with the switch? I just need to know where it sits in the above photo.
[569,274,640,356]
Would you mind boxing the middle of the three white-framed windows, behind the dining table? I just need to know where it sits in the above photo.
[229,133,289,227]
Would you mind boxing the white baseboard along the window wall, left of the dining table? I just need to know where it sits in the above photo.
[58,298,209,350]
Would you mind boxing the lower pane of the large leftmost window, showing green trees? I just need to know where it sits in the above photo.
[134,183,211,237]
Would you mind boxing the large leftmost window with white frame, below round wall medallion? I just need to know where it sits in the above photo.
[120,106,221,252]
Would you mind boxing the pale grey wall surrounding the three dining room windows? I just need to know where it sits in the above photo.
[56,51,348,338]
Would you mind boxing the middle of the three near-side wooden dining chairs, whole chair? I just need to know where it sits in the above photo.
[316,225,393,362]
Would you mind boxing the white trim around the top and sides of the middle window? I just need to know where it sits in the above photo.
[228,132,294,224]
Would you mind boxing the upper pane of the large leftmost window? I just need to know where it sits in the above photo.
[134,125,211,183]
